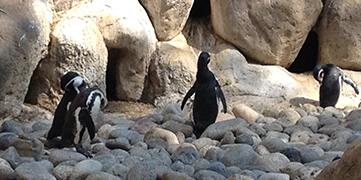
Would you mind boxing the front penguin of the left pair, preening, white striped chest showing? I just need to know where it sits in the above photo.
[59,88,108,157]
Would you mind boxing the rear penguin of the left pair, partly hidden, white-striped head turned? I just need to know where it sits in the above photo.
[47,71,88,140]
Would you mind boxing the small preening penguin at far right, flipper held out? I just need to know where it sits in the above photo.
[313,64,359,108]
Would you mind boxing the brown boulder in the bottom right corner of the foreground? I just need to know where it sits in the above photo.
[316,138,361,180]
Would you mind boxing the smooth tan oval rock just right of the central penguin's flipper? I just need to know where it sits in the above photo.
[232,104,260,124]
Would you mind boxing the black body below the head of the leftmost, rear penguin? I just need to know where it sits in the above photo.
[47,93,73,140]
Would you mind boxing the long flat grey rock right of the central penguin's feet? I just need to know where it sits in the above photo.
[201,118,247,140]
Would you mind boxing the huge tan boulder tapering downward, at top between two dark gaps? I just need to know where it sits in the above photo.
[211,0,322,68]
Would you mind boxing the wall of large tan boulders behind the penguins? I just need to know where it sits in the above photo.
[0,0,361,118]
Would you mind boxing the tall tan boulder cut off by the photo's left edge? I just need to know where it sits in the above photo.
[0,0,53,119]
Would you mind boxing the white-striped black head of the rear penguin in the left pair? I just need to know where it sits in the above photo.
[60,71,88,94]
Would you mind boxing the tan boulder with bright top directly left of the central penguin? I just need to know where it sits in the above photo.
[146,34,197,107]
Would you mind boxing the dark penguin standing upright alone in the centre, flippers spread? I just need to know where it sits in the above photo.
[181,52,227,138]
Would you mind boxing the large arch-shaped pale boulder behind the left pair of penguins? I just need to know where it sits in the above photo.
[29,0,157,109]
